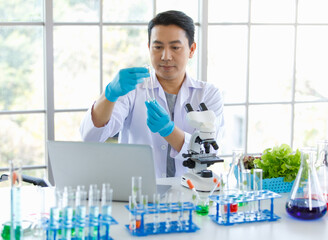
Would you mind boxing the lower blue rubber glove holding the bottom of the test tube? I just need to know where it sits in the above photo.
[146,101,174,137]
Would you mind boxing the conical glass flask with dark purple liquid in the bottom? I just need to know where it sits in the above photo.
[286,148,327,220]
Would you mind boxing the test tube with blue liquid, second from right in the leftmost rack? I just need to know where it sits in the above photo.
[88,185,100,240]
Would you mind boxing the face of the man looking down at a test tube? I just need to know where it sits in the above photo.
[149,25,196,81]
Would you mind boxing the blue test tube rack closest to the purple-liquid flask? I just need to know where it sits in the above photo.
[209,190,281,226]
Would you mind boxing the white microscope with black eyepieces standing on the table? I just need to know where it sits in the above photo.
[181,103,223,192]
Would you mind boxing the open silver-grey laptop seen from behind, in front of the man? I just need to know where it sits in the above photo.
[48,141,170,201]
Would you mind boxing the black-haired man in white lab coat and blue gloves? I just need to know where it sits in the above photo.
[80,11,223,177]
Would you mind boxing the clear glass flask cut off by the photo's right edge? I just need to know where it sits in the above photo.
[315,140,328,207]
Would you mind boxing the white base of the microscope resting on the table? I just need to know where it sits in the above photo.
[181,172,219,192]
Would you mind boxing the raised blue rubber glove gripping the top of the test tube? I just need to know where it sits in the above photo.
[105,67,149,102]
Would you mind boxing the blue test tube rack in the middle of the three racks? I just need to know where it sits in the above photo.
[125,202,199,236]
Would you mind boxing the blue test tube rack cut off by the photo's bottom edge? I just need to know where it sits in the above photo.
[43,214,118,240]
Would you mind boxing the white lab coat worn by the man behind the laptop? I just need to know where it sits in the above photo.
[80,74,224,178]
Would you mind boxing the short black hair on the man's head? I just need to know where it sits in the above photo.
[148,10,195,47]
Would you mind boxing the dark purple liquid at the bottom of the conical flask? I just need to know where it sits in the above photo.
[286,198,327,220]
